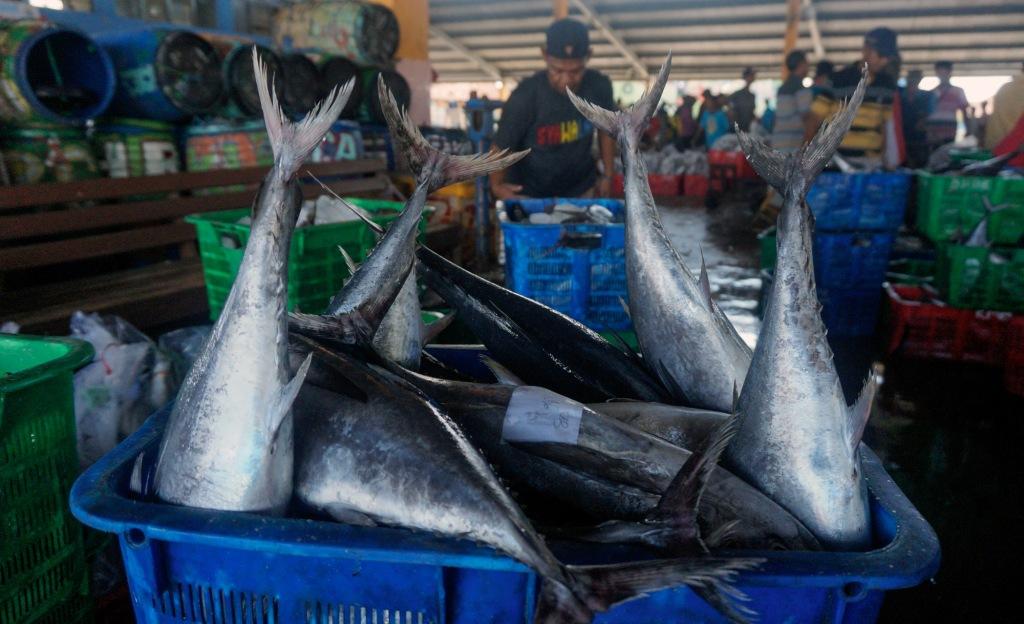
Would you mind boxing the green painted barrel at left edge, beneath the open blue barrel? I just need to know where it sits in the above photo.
[0,122,99,184]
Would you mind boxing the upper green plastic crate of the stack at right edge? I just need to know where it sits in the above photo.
[918,172,1024,245]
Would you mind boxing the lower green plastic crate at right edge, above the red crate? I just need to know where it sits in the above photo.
[936,245,1024,311]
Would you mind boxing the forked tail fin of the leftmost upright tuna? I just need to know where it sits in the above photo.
[253,46,355,178]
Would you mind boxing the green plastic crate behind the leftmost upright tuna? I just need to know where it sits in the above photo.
[185,198,426,320]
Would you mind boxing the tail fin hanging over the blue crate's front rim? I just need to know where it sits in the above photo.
[565,556,764,622]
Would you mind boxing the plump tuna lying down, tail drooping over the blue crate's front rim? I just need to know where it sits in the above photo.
[288,342,757,624]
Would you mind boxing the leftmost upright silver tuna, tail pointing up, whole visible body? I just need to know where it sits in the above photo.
[155,50,352,513]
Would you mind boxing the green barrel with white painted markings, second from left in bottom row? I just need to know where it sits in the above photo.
[92,118,179,177]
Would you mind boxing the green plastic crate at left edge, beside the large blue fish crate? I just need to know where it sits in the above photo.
[0,334,92,624]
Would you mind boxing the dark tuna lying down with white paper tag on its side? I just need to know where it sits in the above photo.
[385,369,818,550]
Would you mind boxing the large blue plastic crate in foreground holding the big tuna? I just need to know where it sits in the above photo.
[71,393,939,624]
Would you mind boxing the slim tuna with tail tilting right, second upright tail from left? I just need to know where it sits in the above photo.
[291,80,528,354]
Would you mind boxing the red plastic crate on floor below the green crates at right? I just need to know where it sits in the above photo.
[885,284,1013,366]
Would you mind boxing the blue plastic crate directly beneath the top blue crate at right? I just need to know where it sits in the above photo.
[814,232,893,290]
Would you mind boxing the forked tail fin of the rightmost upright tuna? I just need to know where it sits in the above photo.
[736,67,867,195]
